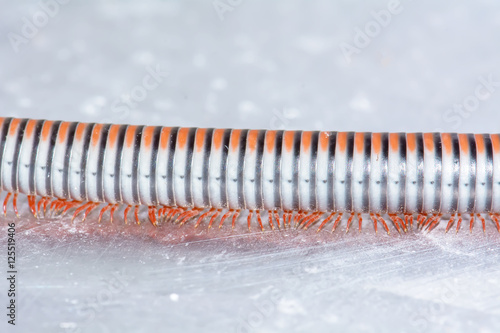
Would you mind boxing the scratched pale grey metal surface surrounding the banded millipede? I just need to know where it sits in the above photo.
[0,0,500,332]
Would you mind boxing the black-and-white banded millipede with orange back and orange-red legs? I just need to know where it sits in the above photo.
[0,118,500,233]
